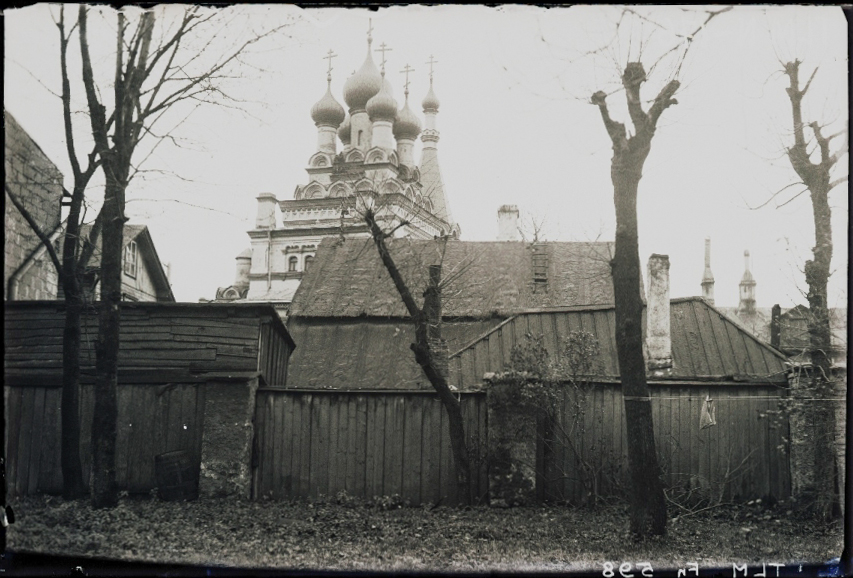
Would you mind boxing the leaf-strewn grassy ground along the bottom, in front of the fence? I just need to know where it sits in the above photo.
[7,496,843,577]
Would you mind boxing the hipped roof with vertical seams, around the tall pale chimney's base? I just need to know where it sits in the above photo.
[449,297,786,388]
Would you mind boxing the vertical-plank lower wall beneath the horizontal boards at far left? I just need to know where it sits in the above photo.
[4,383,204,495]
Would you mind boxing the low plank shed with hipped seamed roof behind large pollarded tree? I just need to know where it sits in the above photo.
[449,297,791,502]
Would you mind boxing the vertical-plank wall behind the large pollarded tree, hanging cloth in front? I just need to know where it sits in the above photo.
[543,385,791,503]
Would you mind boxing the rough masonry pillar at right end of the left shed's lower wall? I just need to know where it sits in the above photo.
[198,377,258,500]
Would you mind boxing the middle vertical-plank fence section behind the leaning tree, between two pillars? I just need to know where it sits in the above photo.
[254,389,488,504]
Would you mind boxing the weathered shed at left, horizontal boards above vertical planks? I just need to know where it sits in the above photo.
[4,301,295,494]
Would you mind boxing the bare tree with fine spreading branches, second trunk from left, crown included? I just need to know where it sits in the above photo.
[60,5,287,507]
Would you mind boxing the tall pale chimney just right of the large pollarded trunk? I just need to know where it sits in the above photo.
[646,254,672,377]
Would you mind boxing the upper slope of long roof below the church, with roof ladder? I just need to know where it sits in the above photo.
[291,238,613,318]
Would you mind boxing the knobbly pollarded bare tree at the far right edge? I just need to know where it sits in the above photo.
[784,60,849,520]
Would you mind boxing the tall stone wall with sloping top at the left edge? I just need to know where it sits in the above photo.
[3,112,62,300]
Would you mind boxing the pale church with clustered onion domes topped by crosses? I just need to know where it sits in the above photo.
[216,28,460,312]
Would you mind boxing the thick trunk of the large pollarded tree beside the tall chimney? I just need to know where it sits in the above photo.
[612,171,666,537]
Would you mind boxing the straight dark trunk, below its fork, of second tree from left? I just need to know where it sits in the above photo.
[92,178,124,508]
